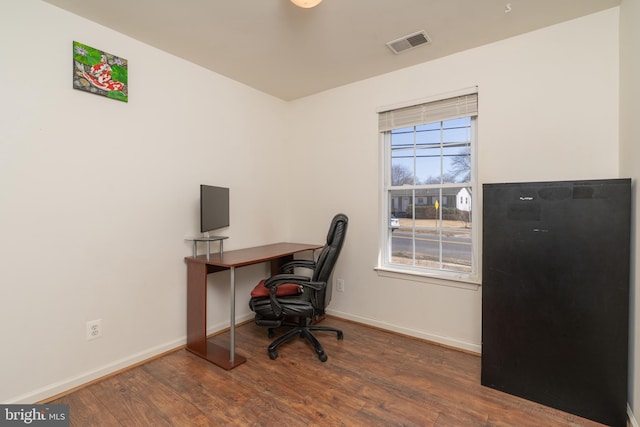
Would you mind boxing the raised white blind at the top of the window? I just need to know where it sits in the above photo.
[378,93,478,132]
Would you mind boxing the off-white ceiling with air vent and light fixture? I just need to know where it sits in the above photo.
[44,0,620,100]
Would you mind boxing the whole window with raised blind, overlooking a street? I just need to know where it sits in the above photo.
[379,91,478,281]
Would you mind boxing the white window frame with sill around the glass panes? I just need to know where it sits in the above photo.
[375,88,481,289]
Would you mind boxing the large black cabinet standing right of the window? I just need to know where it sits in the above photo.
[482,179,631,426]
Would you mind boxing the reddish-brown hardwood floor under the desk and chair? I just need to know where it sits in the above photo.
[51,317,600,427]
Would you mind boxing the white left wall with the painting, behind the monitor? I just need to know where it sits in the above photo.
[0,0,288,402]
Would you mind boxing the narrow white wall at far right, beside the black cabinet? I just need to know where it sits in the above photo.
[620,0,640,425]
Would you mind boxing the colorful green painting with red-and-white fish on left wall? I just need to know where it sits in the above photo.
[73,41,129,102]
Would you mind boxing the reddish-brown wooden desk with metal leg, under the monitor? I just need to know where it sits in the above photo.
[185,243,322,370]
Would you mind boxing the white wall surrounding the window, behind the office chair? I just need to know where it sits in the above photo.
[289,8,619,352]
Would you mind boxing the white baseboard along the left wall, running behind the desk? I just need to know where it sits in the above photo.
[4,313,254,404]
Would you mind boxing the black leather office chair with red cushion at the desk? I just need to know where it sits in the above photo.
[249,214,349,362]
